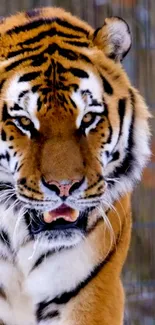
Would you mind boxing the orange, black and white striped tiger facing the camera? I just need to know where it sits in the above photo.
[0,7,151,325]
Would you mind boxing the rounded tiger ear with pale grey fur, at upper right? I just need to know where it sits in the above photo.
[93,17,131,61]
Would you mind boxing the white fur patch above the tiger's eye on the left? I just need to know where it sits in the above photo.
[5,75,39,129]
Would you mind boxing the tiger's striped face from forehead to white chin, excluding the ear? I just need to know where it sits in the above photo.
[0,9,149,246]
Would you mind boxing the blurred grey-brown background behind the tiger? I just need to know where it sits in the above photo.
[0,0,155,325]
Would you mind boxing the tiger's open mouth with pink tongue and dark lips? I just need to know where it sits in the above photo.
[30,204,90,235]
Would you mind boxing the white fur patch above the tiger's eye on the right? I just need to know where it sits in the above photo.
[72,71,104,128]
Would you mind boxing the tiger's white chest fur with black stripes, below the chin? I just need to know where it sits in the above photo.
[0,223,93,325]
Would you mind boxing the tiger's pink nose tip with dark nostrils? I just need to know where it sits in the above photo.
[43,178,84,198]
